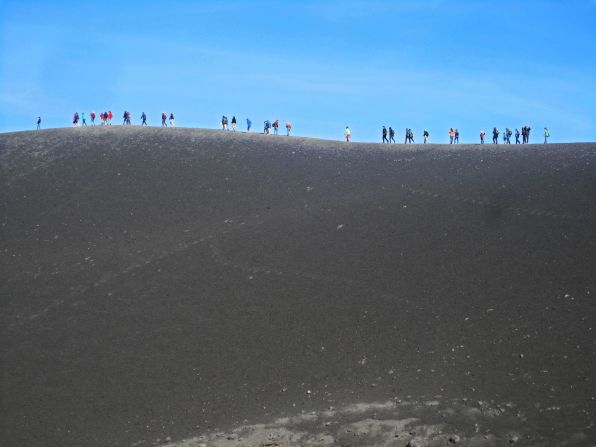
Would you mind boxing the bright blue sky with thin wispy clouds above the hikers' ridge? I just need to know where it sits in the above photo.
[0,0,596,142]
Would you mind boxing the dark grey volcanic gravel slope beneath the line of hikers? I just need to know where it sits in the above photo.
[0,127,596,447]
